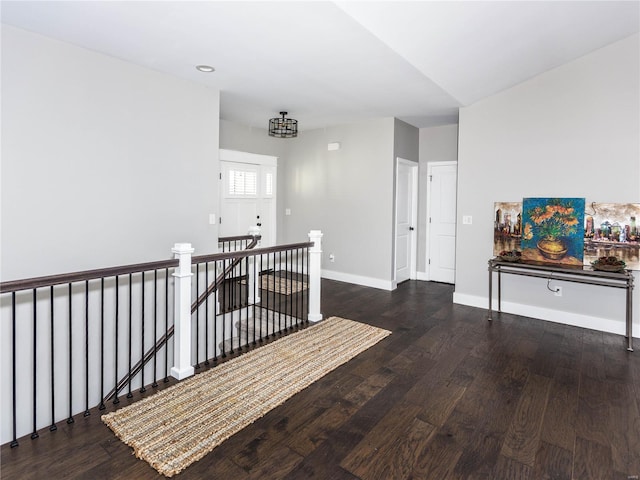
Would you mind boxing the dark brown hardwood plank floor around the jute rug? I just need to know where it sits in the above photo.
[0,280,640,480]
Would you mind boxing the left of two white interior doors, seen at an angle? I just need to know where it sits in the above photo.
[395,158,418,284]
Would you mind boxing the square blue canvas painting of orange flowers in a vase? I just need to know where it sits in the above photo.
[521,198,585,265]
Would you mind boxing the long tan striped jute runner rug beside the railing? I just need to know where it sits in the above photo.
[102,317,391,477]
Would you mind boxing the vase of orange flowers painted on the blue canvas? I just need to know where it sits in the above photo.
[523,199,580,261]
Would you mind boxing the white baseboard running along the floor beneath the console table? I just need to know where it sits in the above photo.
[453,292,626,335]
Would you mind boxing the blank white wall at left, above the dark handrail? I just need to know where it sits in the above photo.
[1,25,219,280]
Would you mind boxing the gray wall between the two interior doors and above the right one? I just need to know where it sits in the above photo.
[417,125,458,276]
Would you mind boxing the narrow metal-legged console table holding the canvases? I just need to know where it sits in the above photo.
[487,258,633,352]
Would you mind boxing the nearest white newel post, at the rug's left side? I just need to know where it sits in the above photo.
[171,243,194,380]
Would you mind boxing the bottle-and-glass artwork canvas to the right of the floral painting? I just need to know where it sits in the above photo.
[584,202,640,270]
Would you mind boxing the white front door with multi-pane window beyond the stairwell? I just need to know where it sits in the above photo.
[218,150,276,247]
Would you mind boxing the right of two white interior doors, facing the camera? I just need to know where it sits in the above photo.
[427,162,458,283]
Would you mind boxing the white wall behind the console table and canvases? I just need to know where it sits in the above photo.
[454,34,640,336]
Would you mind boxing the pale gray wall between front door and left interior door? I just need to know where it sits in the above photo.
[278,118,394,286]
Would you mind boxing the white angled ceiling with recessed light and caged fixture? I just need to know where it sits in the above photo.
[1,0,640,130]
